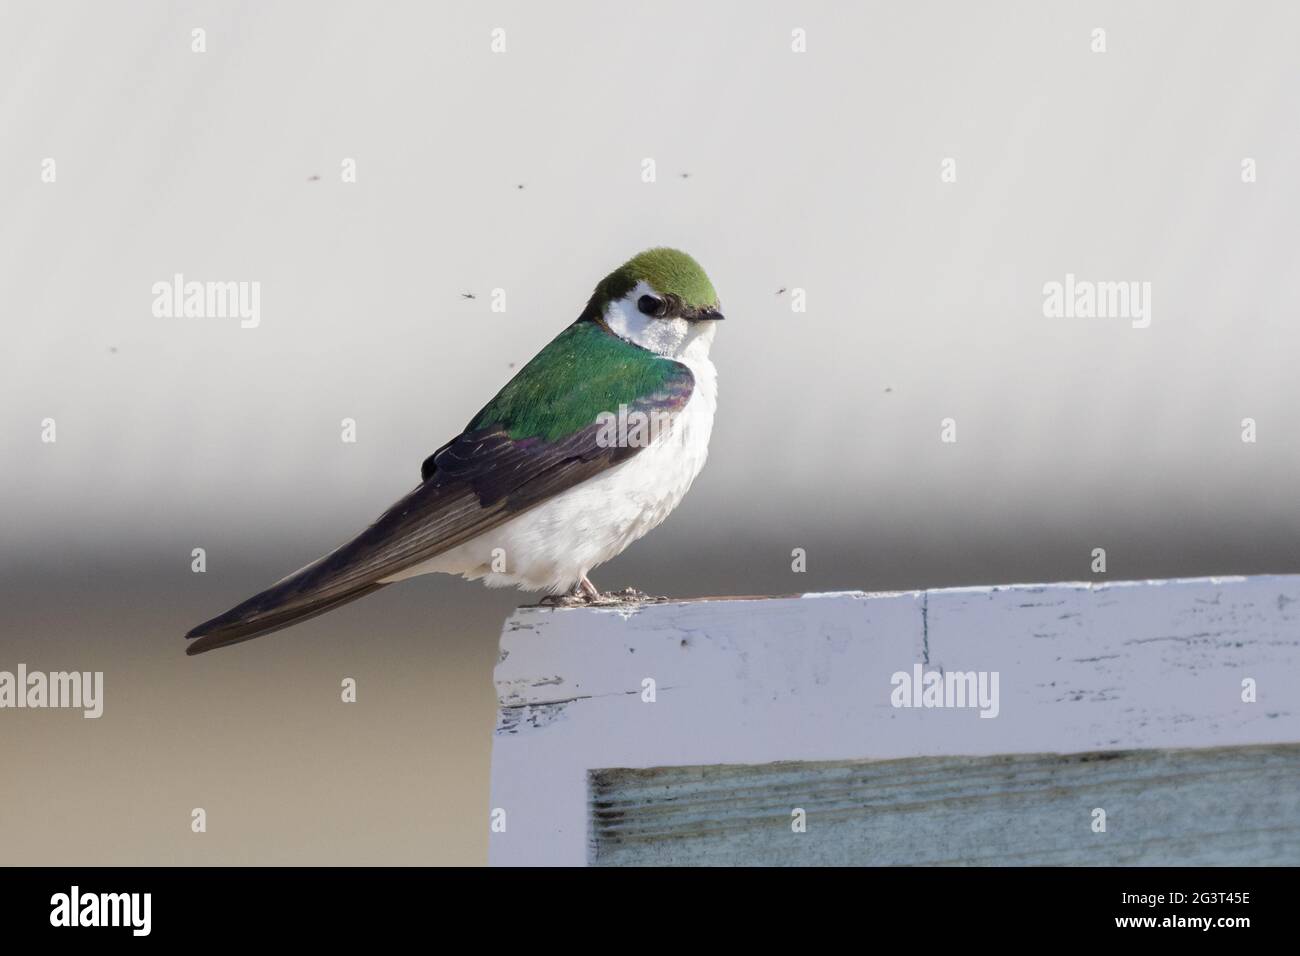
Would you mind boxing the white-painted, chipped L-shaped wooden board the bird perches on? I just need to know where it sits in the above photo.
[489,575,1300,865]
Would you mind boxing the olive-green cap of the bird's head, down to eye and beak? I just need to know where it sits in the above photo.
[585,248,723,321]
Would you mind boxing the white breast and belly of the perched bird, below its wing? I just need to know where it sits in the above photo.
[387,359,718,593]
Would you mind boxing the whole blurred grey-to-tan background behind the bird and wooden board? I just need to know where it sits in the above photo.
[0,1,1300,864]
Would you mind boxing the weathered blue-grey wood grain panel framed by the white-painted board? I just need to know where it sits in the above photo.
[589,745,1300,866]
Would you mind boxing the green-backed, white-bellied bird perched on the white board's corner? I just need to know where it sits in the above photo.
[186,247,723,656]
